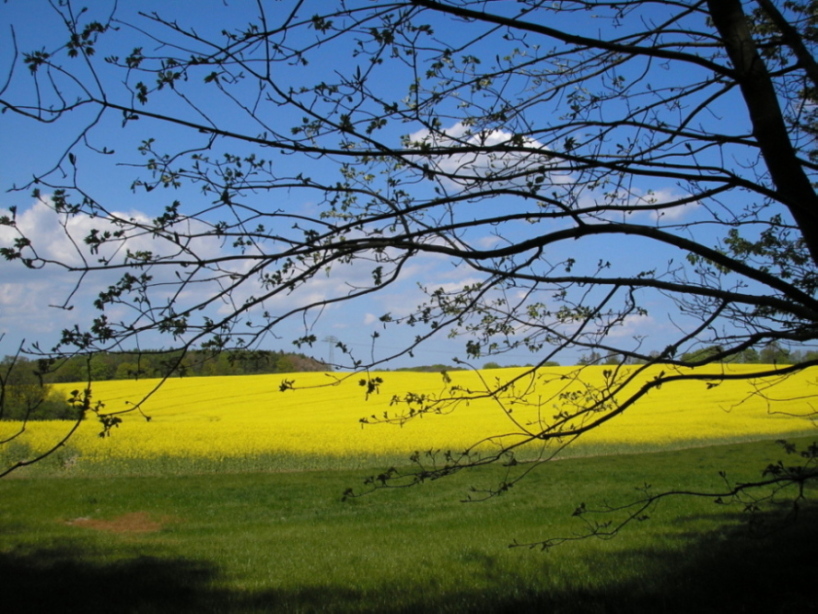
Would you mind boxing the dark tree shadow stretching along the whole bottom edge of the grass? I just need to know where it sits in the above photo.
[6,513,818,614]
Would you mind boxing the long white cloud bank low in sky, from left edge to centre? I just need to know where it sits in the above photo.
[0,200,447,346]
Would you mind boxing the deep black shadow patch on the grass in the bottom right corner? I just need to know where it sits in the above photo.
[556,509,818,614]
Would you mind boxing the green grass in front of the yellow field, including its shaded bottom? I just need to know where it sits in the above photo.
[0,442,818,613]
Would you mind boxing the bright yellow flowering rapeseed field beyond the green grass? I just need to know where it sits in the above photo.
[0,365,818,462]
